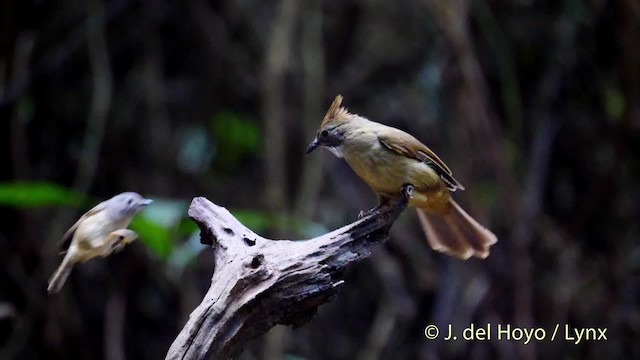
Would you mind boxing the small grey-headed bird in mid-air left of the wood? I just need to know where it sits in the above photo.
[47,192,153,294]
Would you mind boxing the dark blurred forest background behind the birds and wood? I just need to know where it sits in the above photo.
[0,0,640,360]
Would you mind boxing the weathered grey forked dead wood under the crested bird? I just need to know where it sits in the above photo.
[166,189,411,359]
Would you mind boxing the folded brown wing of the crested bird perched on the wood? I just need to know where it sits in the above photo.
[378,128,464,191]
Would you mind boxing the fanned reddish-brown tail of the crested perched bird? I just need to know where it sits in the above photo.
[416,200,498,260]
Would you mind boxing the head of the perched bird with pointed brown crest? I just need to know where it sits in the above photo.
[306,95,354,157]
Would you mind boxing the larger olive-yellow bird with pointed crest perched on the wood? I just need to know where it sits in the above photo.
[307,95,497,259]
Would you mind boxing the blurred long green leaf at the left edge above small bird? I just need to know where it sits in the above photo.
[0,181,86,207]
